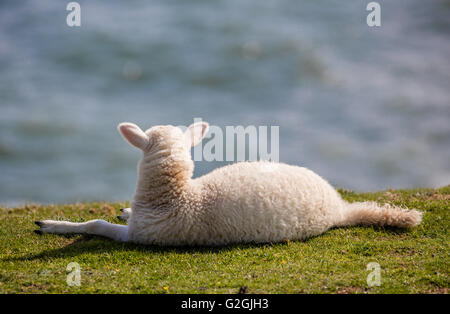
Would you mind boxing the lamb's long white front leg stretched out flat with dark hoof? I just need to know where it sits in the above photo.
[35,219,128,242]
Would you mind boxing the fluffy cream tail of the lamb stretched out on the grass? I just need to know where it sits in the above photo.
[339,202,422,228]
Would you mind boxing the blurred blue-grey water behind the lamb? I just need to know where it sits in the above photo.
[0,0,450,204]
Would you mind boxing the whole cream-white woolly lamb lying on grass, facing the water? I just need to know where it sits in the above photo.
[35,122,422,246]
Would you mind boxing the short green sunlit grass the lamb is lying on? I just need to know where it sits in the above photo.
[0,186,450,293]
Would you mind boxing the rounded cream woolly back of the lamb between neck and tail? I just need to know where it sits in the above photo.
[196,162,342,242]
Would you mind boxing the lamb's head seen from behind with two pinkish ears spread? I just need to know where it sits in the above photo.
[118,122,209,179]
